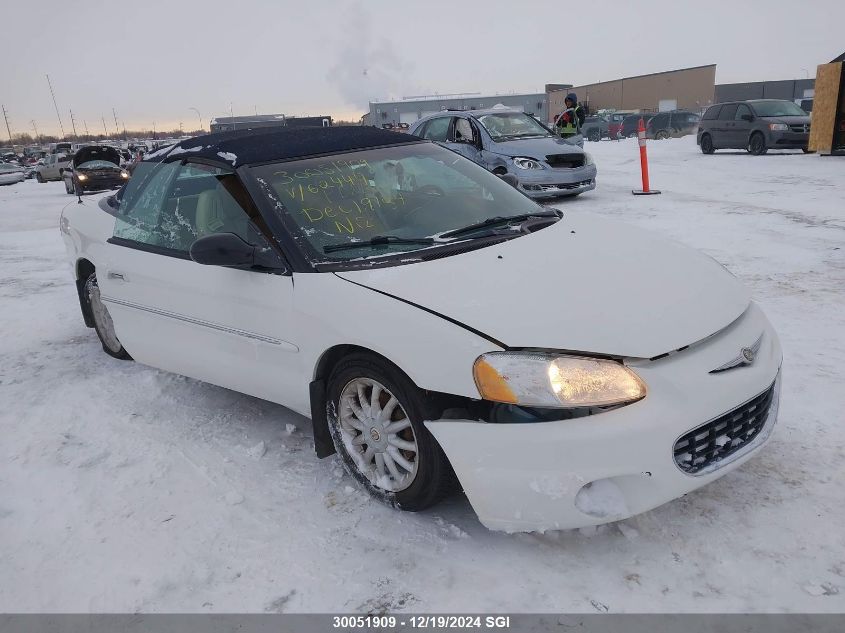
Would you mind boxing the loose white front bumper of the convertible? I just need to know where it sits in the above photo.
[426,303,782,532]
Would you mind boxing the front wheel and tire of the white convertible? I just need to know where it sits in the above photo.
[326,354,455,512]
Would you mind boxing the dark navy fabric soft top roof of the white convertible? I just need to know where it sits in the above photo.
[145,125,423,167]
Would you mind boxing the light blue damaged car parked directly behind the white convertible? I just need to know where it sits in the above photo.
[410,108,596,198]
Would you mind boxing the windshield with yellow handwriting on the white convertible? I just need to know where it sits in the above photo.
[250,143,543,262]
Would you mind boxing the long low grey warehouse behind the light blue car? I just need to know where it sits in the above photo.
[365,92,548,128]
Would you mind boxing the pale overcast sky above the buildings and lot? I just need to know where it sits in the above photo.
[0,0,845,140]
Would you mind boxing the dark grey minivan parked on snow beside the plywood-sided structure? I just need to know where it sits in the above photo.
[696,99,810,155]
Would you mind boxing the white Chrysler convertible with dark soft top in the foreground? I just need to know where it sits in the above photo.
[61,127,781,531]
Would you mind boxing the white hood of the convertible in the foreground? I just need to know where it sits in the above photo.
[336,214,750,358]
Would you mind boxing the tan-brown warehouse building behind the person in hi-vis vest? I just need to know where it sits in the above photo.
[546,64,716,119]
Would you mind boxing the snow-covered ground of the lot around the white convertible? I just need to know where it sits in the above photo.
[0,137,845,612]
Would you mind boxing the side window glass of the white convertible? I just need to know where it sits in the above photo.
[115,162,258,253]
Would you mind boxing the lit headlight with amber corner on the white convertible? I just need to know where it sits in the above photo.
[472,352,646,408]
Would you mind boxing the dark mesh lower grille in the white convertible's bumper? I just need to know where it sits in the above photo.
[674,384,775,475]
